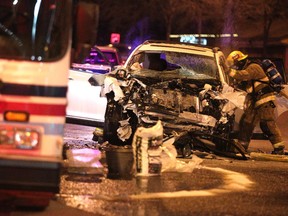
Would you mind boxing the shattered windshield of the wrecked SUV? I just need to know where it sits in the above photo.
[129,52,218,80]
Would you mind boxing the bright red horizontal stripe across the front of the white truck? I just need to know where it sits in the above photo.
[0,102,66,116]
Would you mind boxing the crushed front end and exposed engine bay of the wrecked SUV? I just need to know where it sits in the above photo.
[94,69,248,157]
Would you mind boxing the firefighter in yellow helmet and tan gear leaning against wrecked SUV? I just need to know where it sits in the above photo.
[227,50,285,154]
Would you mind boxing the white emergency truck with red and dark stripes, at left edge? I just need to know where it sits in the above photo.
[0,0,73,208]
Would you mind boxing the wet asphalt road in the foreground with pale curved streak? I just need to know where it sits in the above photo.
[11,124,288,216]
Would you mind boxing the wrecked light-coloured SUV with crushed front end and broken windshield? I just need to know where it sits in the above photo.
[94,41,248,157]
